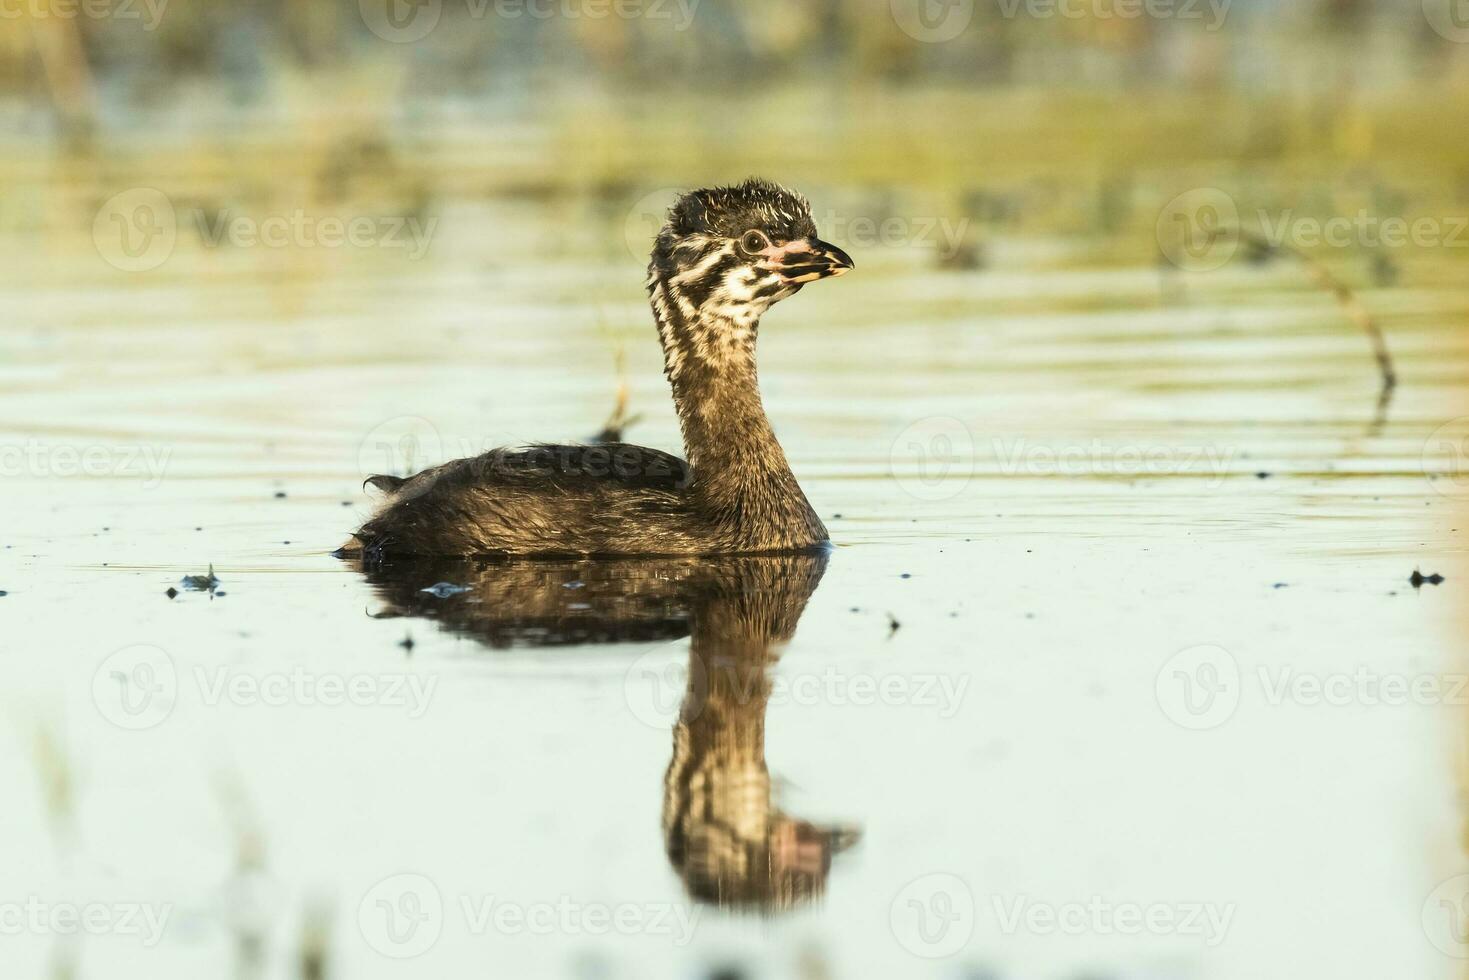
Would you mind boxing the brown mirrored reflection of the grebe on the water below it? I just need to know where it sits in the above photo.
[358,552,858,911]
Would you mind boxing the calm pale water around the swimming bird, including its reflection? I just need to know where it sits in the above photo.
[0,147,1469,980]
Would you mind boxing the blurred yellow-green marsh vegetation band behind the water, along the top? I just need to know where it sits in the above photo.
[0,0,1469,282]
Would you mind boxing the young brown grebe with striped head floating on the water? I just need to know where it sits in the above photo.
[338,179,852,560]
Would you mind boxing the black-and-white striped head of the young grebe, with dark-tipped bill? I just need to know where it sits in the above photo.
[648,178,852,328]
